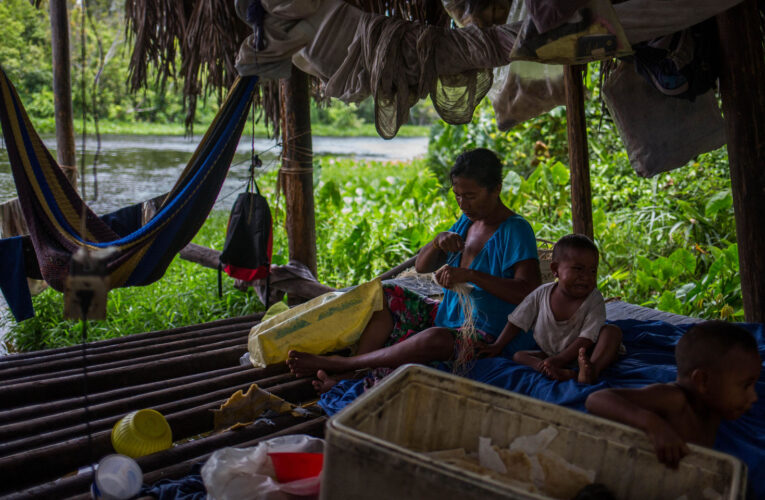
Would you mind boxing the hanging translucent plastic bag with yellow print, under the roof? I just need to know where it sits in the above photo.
[510,0,632,64]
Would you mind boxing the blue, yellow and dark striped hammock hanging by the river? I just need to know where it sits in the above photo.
[0,68,257,318]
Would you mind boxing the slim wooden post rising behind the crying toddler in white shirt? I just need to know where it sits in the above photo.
[563,64,593,239]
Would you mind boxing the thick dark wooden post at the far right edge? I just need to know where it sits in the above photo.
[717,0,765,323]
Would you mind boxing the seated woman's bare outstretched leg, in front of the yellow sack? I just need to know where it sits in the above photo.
[287,327,454,376]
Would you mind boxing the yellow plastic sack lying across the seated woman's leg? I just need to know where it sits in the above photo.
[247,279,383,367]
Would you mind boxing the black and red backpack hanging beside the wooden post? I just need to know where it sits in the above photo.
[218,155,273,298]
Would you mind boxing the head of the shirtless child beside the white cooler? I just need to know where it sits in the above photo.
[675,321,762,420]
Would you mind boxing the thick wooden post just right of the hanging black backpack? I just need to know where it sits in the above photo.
[279,66,317,303]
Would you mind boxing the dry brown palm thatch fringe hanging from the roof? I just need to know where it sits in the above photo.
[125,0,450,135]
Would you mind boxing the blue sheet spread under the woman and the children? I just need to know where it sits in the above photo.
[319,320,765,499]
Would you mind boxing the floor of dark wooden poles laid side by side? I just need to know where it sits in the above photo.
[0,301,700,498]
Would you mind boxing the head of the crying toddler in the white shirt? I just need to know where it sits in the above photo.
[550,234,599,298]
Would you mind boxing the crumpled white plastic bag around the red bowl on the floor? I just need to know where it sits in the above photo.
[201,434,324,500]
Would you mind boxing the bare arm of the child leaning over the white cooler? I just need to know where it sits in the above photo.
[585,384,688,469]
